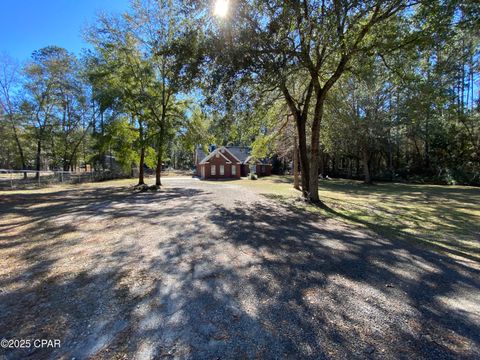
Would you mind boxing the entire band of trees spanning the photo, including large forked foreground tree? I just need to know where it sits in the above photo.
[0,0,480,203]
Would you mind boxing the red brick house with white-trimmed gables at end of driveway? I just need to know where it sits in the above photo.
[195,146,272,179]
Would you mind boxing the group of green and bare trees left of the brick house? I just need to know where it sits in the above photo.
[0,1,210,185]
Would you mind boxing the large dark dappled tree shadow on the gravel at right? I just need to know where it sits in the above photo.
[207,206,480,358]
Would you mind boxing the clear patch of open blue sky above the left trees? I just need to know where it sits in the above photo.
[0,0,129,61]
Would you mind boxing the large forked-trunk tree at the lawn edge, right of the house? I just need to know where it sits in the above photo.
[190,0,428,203]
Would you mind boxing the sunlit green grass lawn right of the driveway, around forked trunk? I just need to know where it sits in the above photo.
[235,176,480,261]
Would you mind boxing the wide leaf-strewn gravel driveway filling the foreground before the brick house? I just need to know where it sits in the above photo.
[0,179,480,359]
